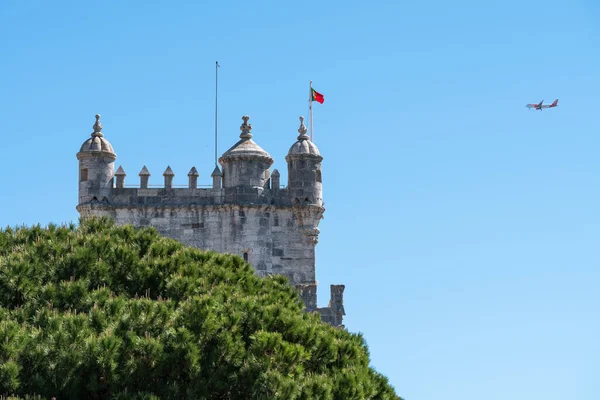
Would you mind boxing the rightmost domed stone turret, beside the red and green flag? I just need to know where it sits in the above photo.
[285,117,323,206]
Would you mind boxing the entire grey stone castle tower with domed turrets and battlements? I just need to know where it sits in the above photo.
[77,115,344,326]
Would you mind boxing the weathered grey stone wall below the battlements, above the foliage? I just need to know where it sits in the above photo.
[81,205,315,285]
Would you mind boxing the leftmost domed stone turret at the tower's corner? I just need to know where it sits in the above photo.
[77,114,117,204]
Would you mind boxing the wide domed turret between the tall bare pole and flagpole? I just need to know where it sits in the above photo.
[219,115,273,189]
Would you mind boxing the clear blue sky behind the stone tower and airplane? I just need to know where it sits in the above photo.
[0,0,600,400]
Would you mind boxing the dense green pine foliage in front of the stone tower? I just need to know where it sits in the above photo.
[0,219,399,400]
